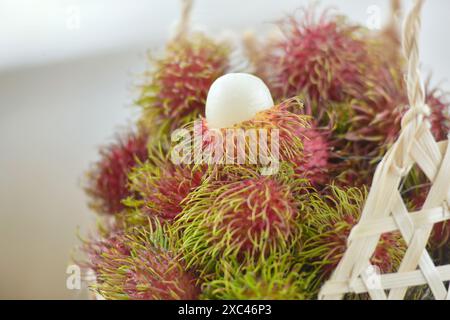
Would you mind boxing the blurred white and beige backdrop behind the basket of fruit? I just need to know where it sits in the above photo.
[0,0,450,299]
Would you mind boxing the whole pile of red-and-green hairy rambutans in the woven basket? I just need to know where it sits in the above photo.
[80,1,450,299]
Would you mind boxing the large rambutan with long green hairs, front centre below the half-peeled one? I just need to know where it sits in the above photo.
[174,171,299,275]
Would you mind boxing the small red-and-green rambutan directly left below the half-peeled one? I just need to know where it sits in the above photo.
[128,159,204,221]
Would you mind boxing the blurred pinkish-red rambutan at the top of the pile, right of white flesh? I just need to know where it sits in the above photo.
[267,8,367,102]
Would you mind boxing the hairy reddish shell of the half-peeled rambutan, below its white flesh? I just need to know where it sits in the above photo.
[177,99,331,185]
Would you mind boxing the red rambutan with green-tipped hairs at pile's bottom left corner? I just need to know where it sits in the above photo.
[84,224,200,300]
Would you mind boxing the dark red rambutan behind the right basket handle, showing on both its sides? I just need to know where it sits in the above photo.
[345,76,450,156]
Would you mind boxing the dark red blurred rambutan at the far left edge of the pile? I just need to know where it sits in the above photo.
[85,132,148,214]
